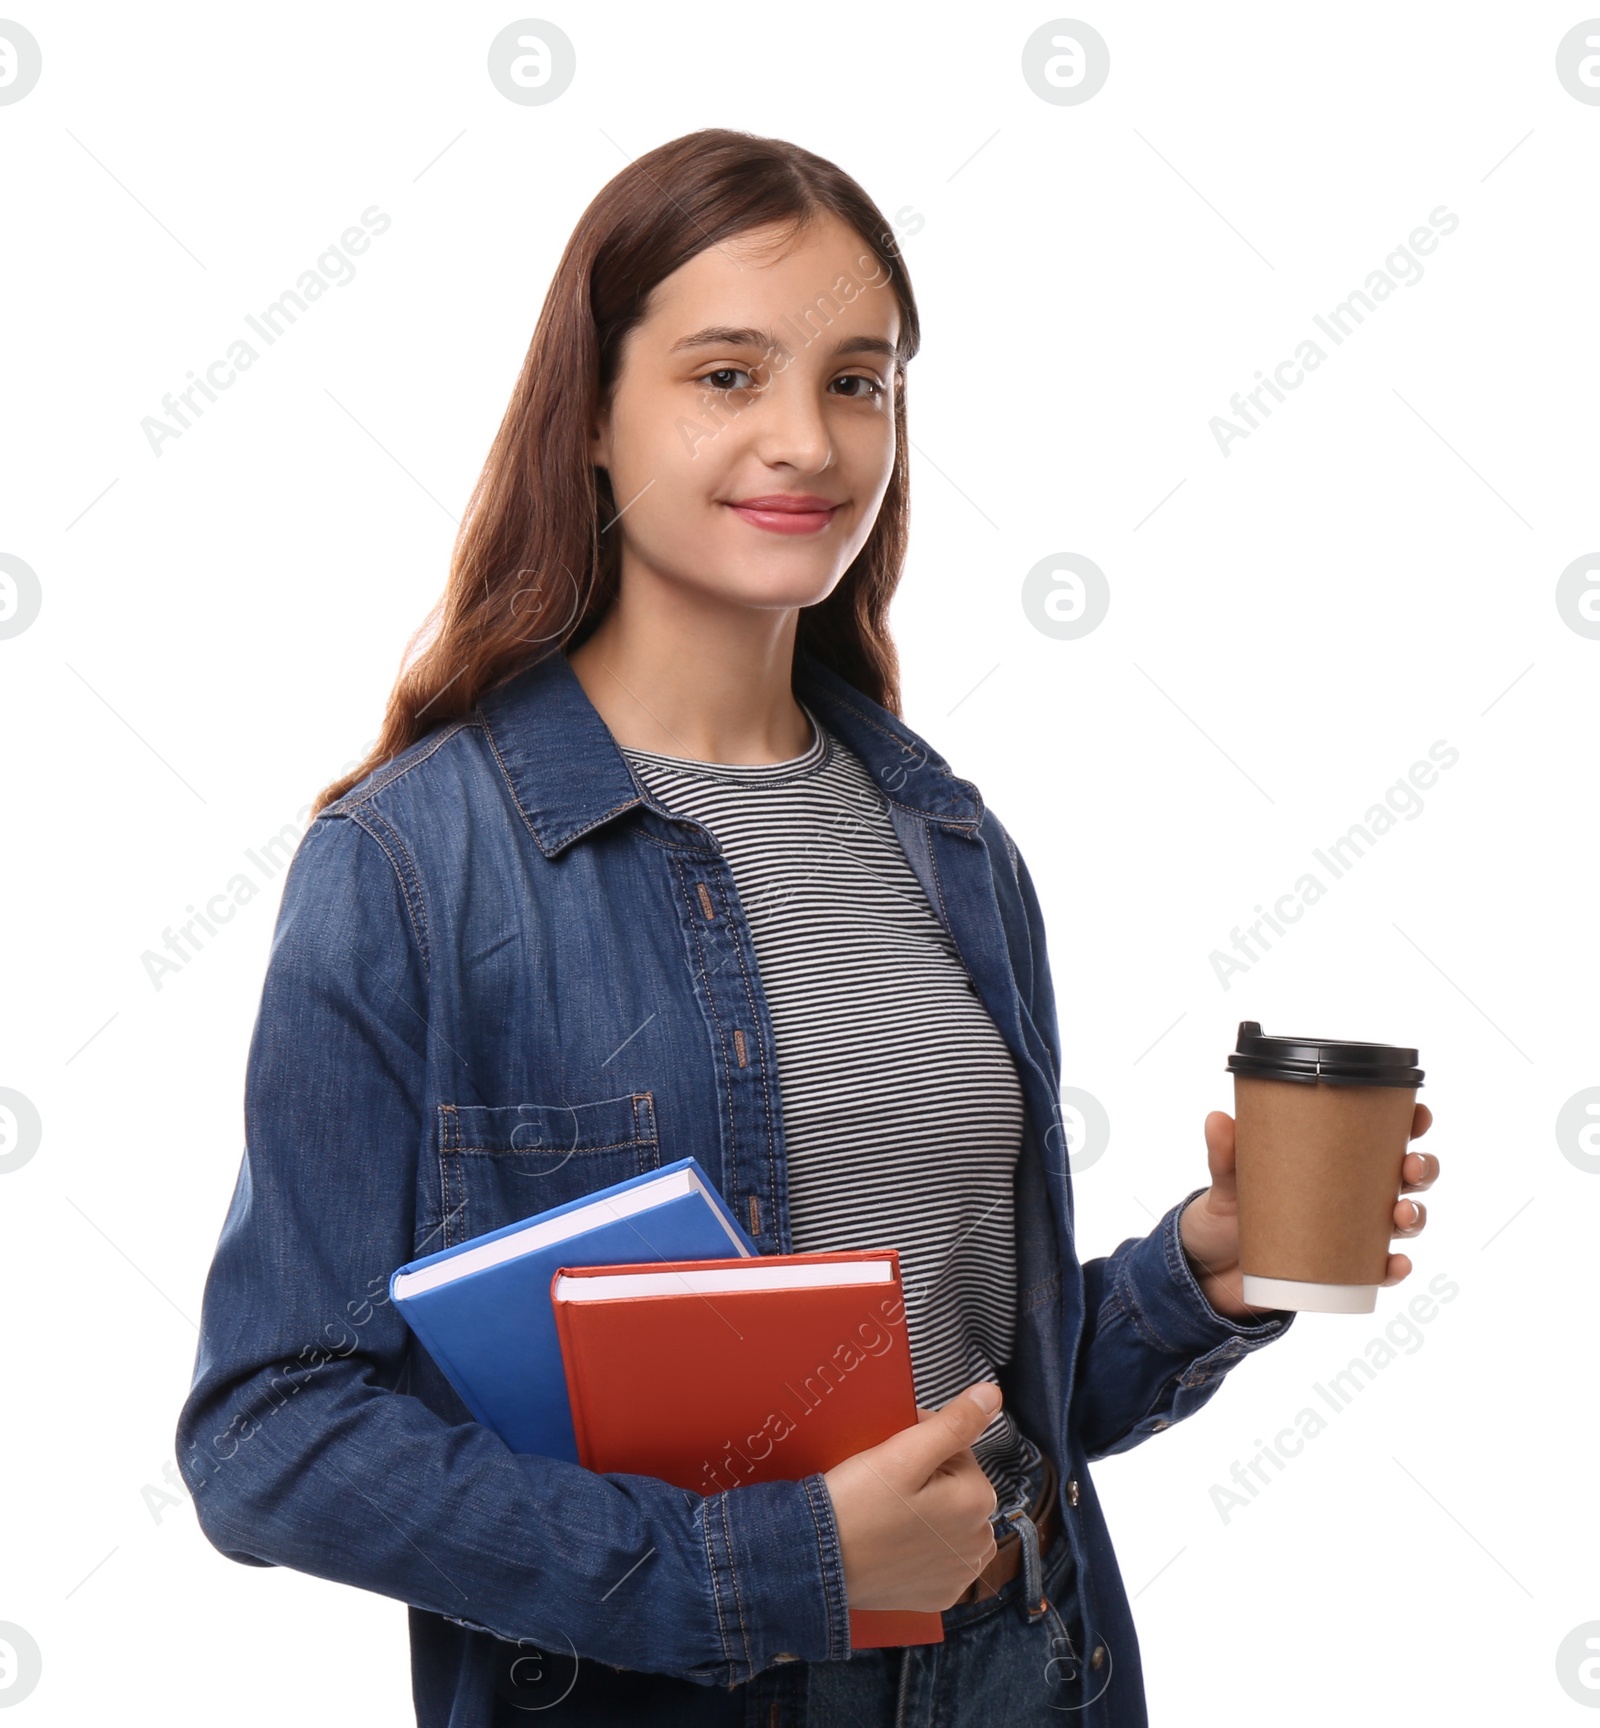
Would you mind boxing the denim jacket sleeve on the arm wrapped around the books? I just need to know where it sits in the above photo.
[178,814,850,1685]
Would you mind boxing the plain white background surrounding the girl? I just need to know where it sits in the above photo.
[0,0,1600,1728]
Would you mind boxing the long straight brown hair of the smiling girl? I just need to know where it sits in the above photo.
[311,128,921,816]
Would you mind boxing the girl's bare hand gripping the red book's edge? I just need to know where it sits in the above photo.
[822,1381,1002,1612]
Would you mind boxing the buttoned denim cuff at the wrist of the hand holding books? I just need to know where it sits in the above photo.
[702,1474,850,1683]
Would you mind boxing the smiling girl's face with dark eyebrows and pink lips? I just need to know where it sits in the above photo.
[591,216,900,622]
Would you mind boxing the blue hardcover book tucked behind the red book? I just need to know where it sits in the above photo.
[389,1158,759,1464]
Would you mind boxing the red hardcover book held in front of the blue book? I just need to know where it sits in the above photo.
[549,1248,945,1650]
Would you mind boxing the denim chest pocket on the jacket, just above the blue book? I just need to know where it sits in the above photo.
[439,1092,662,1248]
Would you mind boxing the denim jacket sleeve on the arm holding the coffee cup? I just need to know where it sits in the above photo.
[1000,828,1294,1458]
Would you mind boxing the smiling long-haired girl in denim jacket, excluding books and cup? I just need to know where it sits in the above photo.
[178,131,1438,1728]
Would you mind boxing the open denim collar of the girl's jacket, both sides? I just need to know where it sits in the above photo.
[479,646,983,857]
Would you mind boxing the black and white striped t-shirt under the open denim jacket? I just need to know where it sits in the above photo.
[624,703,1023,1505]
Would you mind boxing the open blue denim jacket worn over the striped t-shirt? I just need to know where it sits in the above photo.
[178,650,1292,1728]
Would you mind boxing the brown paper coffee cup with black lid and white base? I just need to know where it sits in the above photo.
[1229,1020,1422,1313]
